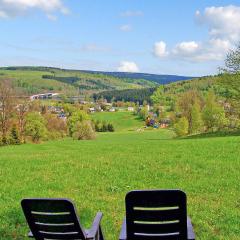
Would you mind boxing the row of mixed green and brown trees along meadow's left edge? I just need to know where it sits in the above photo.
[0,79,114,145]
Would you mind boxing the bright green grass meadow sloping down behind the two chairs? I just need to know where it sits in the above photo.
[0,112,240,240]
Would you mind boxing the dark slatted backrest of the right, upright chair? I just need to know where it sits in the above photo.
[126,190,187,240]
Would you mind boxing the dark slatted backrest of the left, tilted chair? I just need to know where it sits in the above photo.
[21,199,86,240]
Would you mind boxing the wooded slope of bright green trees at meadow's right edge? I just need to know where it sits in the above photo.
[151,44,240,136]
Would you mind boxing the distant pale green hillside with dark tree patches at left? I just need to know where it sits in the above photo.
[0,67,157,95]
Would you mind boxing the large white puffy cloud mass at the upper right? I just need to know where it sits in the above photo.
[154,5,240,62]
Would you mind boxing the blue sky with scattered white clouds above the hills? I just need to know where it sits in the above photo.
[0,0,240,76]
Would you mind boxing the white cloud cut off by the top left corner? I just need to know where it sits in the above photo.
[0,0,69,20]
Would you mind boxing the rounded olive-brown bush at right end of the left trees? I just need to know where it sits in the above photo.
[72,121,96,140]
